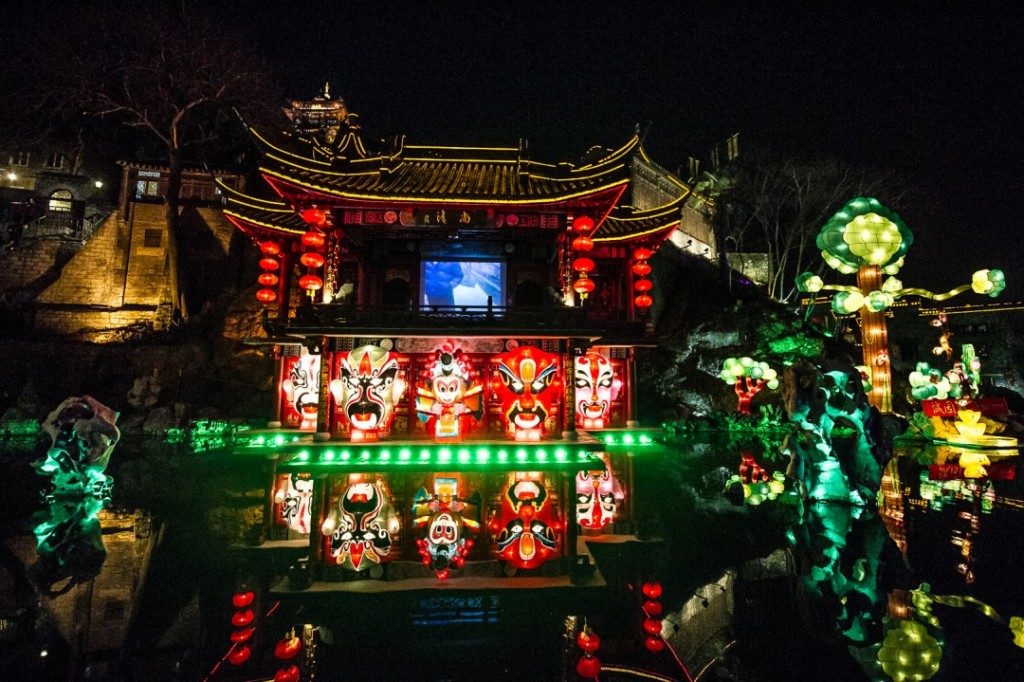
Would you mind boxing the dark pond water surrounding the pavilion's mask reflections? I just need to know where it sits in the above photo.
[0,432,1024,680]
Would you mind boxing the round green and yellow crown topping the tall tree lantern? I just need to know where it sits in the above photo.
[817,197,913,272]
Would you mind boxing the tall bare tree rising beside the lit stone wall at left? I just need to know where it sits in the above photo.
[36,3,275,316]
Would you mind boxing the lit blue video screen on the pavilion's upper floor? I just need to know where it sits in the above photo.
[421,260,505,306]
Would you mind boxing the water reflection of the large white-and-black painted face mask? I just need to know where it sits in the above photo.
[321,481,399,570]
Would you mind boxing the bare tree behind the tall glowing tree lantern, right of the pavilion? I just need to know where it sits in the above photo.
[718,153,906,302]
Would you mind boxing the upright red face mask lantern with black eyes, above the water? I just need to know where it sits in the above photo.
[494,346,558,440]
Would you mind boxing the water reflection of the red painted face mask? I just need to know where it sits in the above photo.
[490,474,561,569]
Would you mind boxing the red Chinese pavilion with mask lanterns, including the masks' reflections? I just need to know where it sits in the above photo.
[221,90,692,585]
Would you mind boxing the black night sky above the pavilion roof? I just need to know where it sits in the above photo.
[7,0,1024,299]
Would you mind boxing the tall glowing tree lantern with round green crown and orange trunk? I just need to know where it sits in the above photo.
[797,197,1007,412]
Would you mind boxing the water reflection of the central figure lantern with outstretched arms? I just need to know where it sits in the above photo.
[413,477,480,580]
